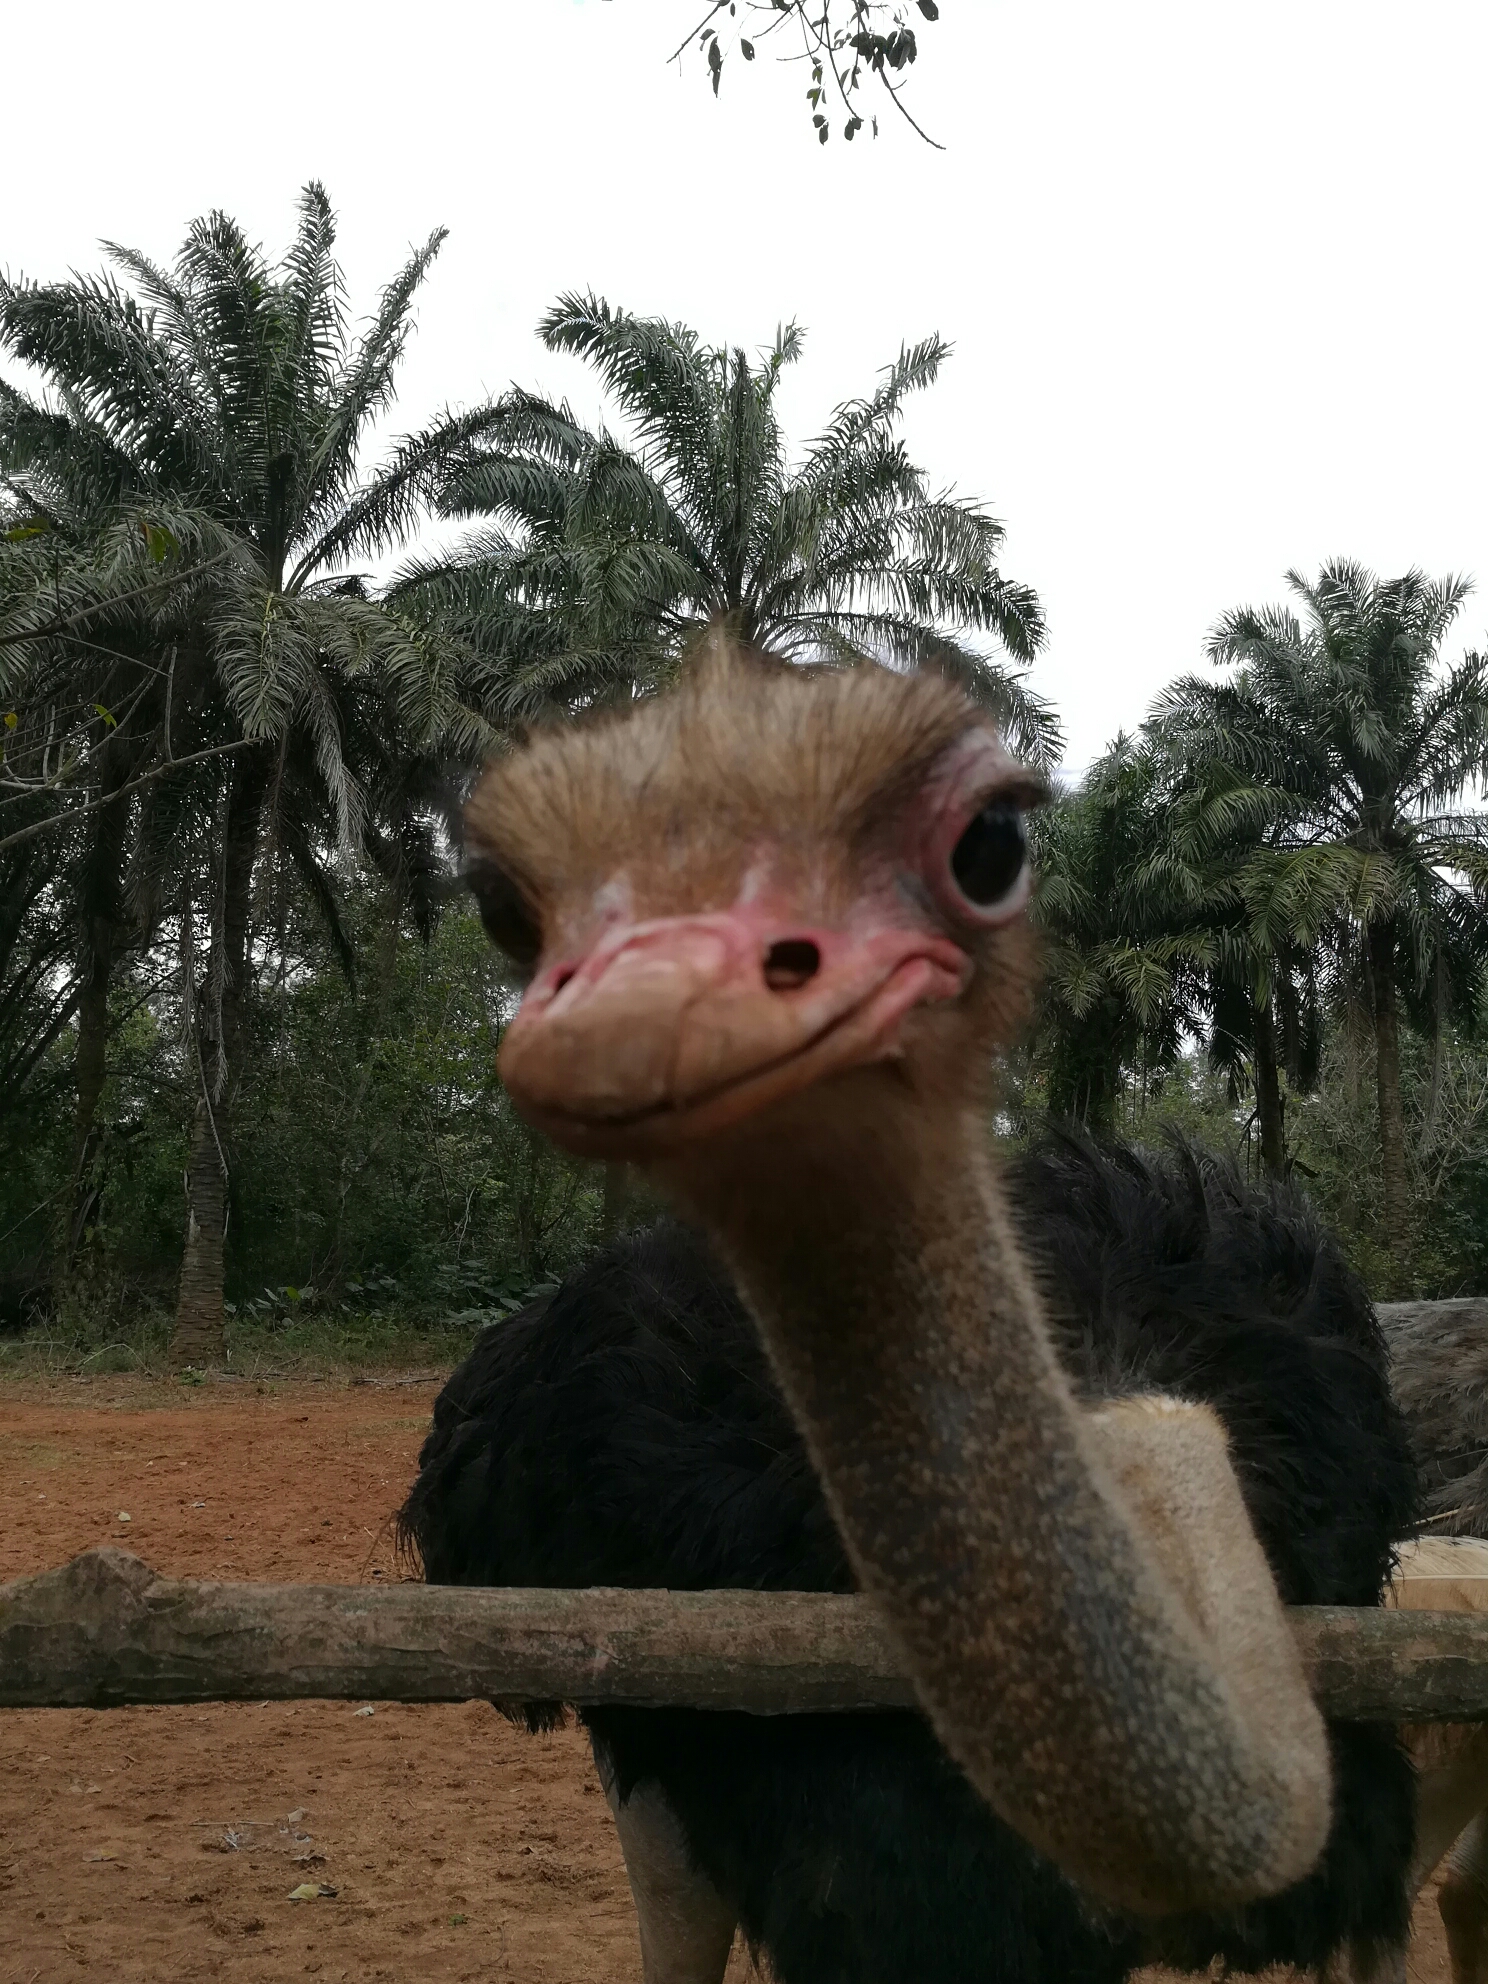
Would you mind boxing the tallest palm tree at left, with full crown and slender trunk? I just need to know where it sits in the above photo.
[0,185,503,1361]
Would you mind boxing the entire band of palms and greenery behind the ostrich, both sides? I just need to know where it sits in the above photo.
[0,186,1488,1361]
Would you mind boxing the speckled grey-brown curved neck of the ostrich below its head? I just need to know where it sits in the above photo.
[663,1071,1329,1915]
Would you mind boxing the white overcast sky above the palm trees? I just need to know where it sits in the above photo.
[0,0,1488,766]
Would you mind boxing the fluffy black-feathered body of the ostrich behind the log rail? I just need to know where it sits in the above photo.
[405,1143,1413,1984]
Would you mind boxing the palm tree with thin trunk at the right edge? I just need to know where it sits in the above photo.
[1157,559,1488,1264]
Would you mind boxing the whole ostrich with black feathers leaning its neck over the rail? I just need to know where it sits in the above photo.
[409,651,1413,1984]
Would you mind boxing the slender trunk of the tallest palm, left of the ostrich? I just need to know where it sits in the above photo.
[171,752,268,1369]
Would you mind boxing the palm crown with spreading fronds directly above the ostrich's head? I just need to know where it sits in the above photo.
[395,296,1059,760]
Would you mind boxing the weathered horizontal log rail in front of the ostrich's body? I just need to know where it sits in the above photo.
[0,1548,1488,1722]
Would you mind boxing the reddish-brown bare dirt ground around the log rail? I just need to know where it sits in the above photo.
[0,1379,1448,1984]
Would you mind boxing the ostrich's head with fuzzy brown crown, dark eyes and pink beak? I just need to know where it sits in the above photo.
[468,649,1042,1165]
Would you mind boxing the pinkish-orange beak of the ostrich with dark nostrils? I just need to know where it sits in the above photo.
[498,909,970,1159]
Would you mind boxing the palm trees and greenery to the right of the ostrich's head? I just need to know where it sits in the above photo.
[1034,561,1488,1294]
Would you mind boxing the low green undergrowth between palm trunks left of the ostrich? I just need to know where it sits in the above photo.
[0,892,603,1347]
